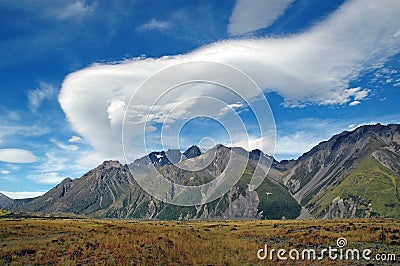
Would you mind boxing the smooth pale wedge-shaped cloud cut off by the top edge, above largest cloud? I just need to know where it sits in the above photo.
[228,0,293,35]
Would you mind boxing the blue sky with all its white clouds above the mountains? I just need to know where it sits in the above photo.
[0,0,400,198]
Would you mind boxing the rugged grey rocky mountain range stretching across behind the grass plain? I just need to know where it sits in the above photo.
[0,124,400,219]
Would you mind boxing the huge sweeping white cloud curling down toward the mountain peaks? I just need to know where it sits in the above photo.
[59,0,400,164]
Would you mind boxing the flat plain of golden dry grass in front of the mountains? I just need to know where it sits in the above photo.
[0,218,400,265]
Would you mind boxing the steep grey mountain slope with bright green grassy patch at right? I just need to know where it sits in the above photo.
[283,124,400,218]
